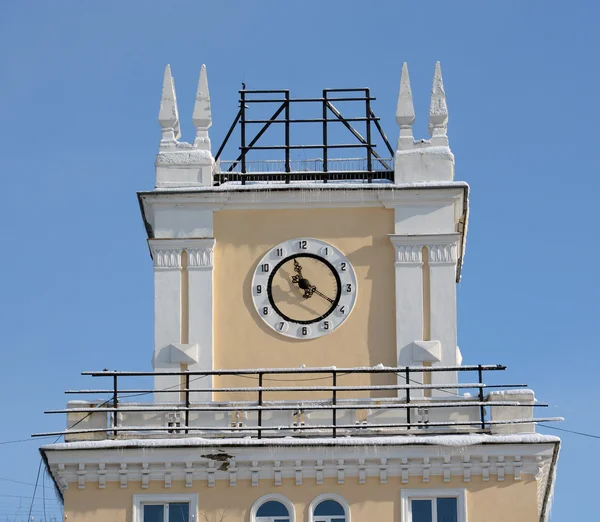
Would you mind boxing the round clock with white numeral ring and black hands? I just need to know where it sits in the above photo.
[252,238,358,339]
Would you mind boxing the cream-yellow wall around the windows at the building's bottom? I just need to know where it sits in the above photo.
[65,475,539,522]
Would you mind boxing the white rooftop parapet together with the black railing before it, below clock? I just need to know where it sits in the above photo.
[34,365,562,442]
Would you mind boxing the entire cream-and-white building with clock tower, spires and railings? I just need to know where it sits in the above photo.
[41,64,560,522]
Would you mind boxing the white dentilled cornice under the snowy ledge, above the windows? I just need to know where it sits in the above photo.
[45,436,554,491]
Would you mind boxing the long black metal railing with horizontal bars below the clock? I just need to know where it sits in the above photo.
[34,365,562,438]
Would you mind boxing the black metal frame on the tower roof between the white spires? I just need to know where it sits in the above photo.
[214,88,394,184]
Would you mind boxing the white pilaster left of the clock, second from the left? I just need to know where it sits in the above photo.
[186,238,215,402]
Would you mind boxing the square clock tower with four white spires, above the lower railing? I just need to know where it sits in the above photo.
[139,64,468,401]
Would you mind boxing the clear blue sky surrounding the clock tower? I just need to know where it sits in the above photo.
[0,0,600,522]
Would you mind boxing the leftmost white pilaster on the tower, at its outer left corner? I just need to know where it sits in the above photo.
[148,239,182,402]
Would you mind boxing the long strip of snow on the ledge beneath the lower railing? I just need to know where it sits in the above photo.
[40,433,560,451]
